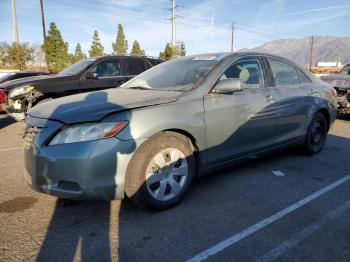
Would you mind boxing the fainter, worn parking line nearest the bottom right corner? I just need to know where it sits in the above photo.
[256,200,350,262]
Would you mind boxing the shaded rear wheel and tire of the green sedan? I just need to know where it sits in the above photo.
[302,112,328,155]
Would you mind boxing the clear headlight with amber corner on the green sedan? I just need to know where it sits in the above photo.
[49,121,128,146]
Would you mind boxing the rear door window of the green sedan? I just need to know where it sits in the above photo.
[268,58,299,86]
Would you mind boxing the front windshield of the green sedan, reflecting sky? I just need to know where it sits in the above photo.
[122,56,223,90]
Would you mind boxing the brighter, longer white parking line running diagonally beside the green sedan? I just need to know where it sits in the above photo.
[187,175,350,262]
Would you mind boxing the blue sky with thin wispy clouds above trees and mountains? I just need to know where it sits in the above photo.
[0,0,350,56]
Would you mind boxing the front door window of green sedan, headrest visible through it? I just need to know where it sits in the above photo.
[220,59,264,88]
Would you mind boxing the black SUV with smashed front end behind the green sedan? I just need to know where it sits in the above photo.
[0,55,163,120]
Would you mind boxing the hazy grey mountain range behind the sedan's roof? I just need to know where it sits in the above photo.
[239,36,350,67]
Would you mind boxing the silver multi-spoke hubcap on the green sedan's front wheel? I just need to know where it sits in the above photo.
[146,148,188,201]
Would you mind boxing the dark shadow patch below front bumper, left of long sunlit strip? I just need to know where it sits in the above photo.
[36,200,111,261]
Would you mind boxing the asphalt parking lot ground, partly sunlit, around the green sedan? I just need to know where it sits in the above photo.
[0,115,350,262]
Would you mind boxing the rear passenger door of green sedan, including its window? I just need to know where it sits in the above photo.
[267,57,312,143]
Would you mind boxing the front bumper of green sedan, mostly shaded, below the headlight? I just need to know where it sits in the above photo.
[24,117,143,200]
